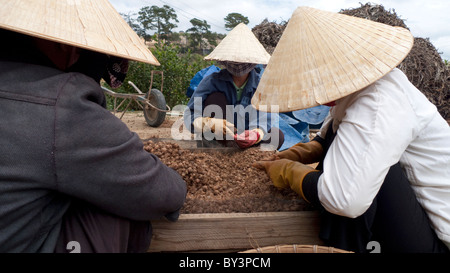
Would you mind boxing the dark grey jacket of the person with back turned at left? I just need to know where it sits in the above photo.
[0,61,186,252]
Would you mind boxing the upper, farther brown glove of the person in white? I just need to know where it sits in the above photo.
[264,140,323,164]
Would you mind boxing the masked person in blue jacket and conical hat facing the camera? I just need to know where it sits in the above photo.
[184,23,284,149]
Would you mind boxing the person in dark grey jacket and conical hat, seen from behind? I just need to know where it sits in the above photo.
[0,0,186,253]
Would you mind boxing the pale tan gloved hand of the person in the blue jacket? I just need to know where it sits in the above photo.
[192,117,235,140]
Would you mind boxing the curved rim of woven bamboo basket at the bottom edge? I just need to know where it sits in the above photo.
[240,244,353,253]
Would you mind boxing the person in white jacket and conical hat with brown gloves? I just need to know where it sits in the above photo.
[252,7,450,253]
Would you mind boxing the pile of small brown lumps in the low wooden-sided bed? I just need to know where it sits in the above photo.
[144,141,311,214]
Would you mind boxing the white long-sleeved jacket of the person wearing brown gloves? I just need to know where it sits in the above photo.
[318,69,450,248]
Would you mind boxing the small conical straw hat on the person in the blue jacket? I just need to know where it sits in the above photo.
[205,23,270,64]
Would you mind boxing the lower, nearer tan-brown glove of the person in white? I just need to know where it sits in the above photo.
[253,159,317,202]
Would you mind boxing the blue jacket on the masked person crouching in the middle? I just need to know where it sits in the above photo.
[184,69,273,133]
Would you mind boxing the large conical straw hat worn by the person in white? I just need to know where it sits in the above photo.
[252,7,414,112]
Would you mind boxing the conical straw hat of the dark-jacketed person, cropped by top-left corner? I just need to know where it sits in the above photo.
[0,0,159,65]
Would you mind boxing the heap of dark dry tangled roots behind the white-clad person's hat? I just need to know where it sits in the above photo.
[252,3,450,120]
